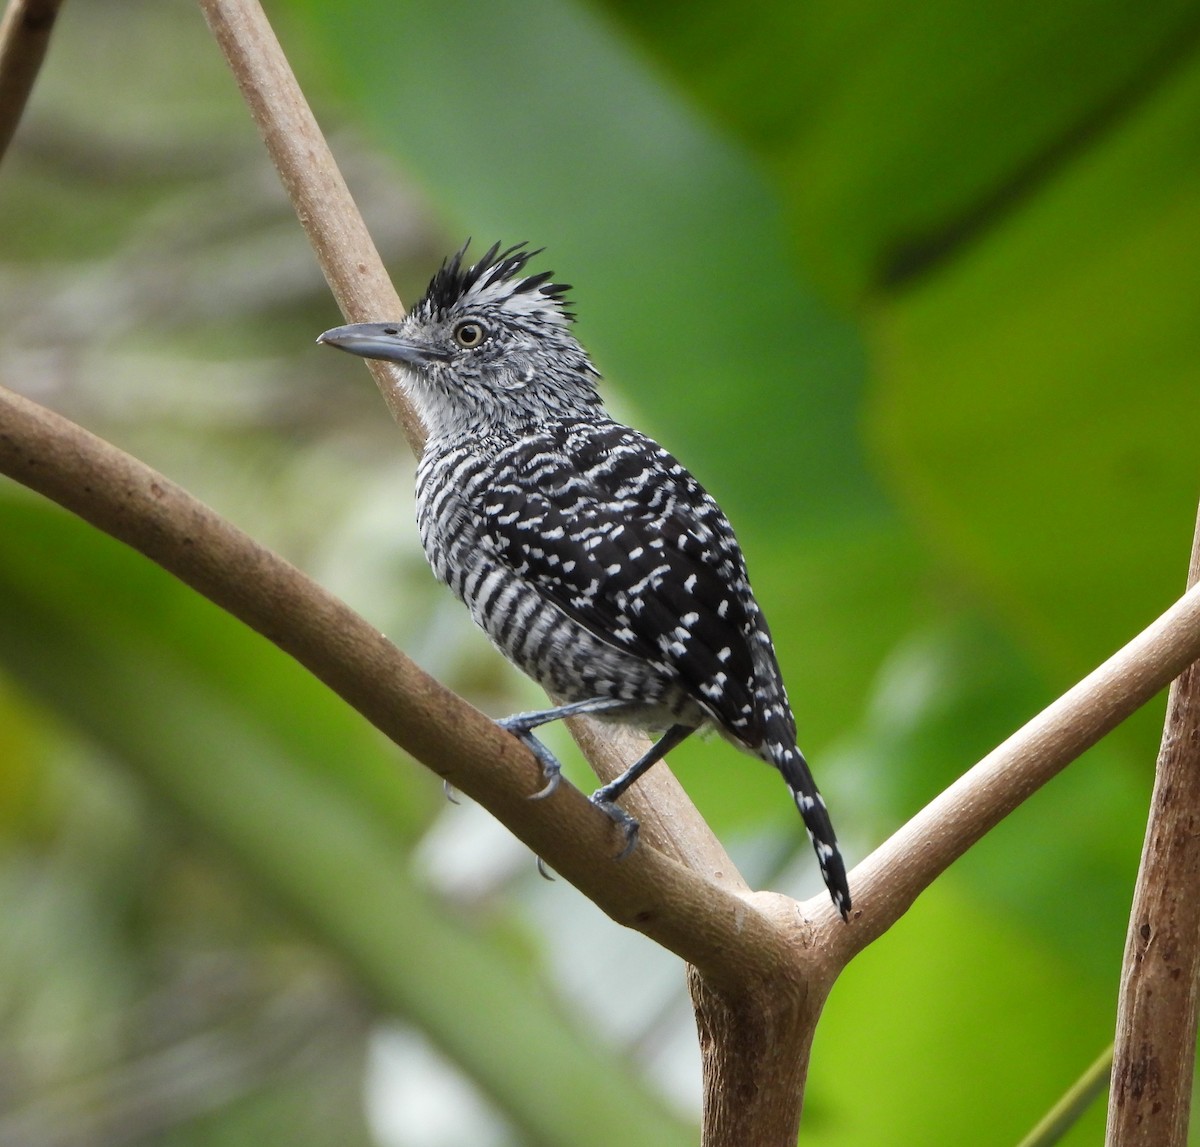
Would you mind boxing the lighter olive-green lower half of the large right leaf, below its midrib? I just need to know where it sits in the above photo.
[872,49,1200,679]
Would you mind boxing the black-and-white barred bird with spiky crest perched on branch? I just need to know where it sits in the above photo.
[318,244,850,919]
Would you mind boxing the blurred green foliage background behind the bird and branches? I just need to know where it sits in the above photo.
[0,0,1200,1147]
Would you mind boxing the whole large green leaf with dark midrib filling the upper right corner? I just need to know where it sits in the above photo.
[568,0,1200,724]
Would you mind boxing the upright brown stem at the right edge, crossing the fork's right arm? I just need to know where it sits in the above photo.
[1105,520,1200,1147]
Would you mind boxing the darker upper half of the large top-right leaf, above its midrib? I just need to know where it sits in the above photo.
[604,0,1200,296]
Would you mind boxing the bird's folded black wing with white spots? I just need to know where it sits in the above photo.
[478,424,778,745]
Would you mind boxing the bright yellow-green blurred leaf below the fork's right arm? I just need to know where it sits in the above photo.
[800,879,1111,1147]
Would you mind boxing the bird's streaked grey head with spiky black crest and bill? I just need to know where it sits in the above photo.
[317,244,600,438]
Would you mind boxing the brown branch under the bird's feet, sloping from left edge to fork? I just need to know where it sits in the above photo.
[0,388,782,985]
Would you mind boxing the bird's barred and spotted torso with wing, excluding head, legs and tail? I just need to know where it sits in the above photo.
[418,418,794,751]
